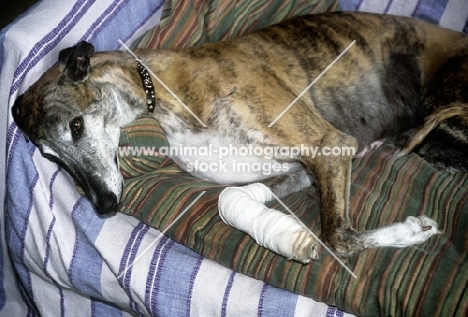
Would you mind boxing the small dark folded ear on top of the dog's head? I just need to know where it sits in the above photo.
[59,41,94,81]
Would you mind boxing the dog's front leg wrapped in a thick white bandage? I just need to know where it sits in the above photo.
[218,183,318,263]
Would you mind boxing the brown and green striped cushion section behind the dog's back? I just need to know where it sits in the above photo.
[134,0,339,48]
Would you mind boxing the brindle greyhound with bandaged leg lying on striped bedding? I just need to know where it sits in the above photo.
[12,13,468,263]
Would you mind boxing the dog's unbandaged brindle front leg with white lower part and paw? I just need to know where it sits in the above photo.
[302,132,439,256]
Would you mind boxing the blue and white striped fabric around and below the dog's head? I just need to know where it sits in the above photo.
[0,0,352,317]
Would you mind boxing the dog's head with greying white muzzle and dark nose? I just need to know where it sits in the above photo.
[12,42,123,214]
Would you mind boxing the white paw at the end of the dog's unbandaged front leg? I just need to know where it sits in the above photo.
[400,216,442,246]
